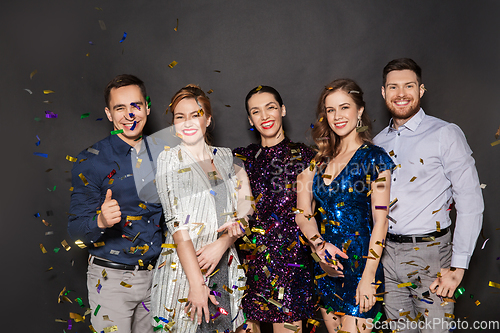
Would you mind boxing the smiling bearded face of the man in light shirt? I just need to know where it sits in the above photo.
[382,69,424,123]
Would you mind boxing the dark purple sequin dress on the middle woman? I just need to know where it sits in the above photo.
[233,138,315,323]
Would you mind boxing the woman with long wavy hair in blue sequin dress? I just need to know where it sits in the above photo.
[296,79,394,332]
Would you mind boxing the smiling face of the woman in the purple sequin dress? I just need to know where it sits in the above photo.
[248,92,286,140]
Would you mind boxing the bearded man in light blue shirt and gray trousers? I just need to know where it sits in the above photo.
[374,58,484,332]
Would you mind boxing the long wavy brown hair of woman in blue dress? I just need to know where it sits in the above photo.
[312,79,372,163]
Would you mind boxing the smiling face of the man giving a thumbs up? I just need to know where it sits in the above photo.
[104,85,150,146]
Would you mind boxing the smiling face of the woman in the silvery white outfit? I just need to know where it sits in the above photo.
[173,98,212,145]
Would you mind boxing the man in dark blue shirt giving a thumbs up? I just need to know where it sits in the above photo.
[68,74,163,333]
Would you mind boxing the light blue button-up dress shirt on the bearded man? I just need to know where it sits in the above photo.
[373,109,484,268]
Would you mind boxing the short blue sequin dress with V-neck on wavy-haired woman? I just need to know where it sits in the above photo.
[313,144,394,318]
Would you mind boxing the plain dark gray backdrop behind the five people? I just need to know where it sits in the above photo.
[0,0,500,332]
